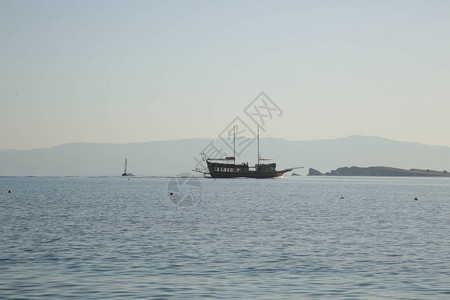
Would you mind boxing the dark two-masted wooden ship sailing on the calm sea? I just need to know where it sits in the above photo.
[194,127,302,178]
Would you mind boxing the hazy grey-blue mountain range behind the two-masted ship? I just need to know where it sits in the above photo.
[0,136,450,176]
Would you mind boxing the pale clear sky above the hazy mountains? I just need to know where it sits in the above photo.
[0,0,450,150]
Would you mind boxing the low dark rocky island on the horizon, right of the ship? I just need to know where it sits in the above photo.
[308,167,450,177]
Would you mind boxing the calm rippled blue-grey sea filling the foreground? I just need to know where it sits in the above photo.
[0,176,450,299]
